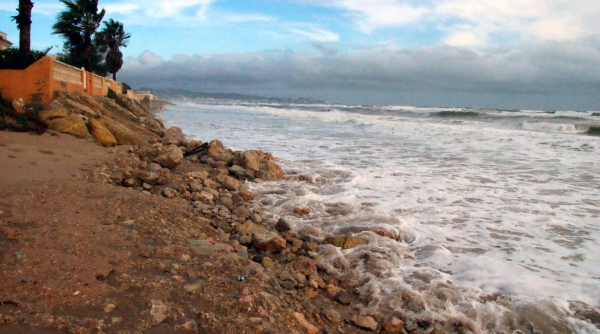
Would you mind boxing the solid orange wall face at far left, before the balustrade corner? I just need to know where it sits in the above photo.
[0,57,53,104]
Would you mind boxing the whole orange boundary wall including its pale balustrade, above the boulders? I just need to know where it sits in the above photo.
[0,57,123,104]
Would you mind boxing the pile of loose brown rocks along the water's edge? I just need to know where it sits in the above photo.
[88,127,418,333]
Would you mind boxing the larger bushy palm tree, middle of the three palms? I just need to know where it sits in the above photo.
[52,0,106,71]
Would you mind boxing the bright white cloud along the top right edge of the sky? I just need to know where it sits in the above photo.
[308,0,600,46]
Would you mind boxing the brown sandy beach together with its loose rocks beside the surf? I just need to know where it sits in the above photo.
[0,93,403,333]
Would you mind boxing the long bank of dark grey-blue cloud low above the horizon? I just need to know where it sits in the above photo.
[119,36,600,109]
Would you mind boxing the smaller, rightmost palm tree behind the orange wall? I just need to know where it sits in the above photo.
[95,19,131,80]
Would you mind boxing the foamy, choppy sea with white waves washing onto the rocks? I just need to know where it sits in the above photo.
[158,100,600,333]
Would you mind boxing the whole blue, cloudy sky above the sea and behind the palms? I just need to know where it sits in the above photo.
[0,0,600,110]
